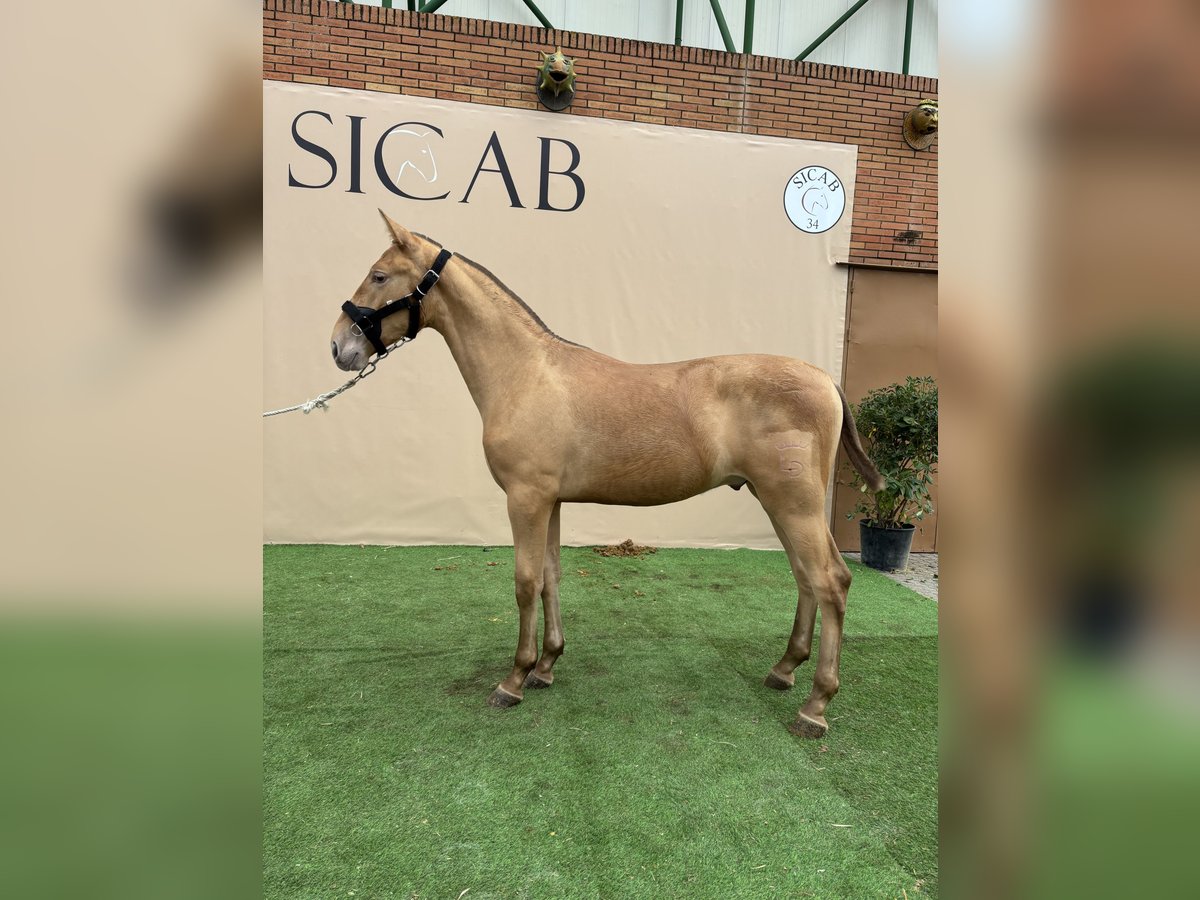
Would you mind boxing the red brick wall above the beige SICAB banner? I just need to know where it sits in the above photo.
[263,0,937,269]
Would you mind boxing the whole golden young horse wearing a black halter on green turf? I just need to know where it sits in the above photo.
[332,210,882,738]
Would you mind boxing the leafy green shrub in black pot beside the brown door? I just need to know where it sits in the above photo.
[850,376,937,571]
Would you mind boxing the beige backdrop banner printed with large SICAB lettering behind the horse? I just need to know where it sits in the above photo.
[267,82,857,547]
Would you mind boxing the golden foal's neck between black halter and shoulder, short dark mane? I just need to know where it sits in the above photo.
[426,258,556,420]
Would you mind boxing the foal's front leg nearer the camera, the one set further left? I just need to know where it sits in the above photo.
[487,488,556,709]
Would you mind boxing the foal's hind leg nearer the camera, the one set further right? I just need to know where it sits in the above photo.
[760,496,851,738]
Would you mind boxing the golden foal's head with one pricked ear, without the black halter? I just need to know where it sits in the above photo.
[330,210,430,372]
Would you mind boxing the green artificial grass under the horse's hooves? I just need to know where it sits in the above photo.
[263,546,937,900]
